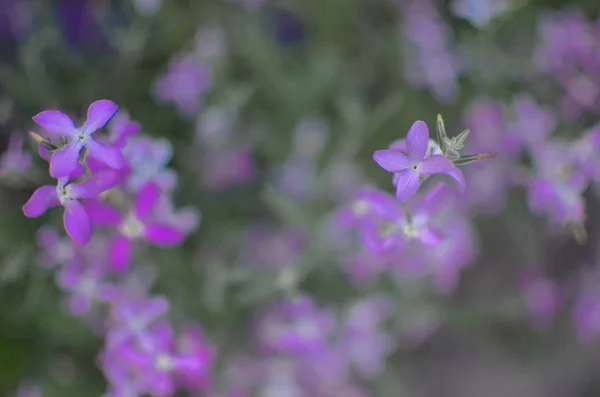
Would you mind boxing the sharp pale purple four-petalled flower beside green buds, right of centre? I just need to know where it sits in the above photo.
[373,121,463,203]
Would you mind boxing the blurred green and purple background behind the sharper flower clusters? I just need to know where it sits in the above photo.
[0,0,600,397]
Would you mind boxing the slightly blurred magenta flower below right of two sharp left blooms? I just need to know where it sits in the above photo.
[106,183,185,272]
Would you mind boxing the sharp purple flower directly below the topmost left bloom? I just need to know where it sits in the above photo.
[23,171,118,244]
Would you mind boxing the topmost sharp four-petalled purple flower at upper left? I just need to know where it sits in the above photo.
[33,99,126,178]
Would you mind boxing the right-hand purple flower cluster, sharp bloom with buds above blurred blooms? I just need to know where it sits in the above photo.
[335,117,494,292]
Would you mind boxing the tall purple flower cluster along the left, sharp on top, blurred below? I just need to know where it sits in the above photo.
[23,100,214,396]
